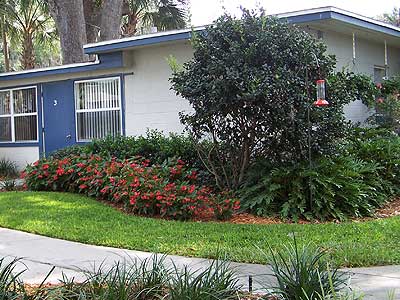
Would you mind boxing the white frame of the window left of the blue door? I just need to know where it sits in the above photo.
[0,85,39,144]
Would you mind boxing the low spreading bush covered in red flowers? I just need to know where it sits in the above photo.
[24,155,239,220]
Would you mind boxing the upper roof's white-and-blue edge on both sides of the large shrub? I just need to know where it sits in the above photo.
[83,6,400,54]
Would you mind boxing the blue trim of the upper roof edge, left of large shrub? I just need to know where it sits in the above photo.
[85,31,192,54]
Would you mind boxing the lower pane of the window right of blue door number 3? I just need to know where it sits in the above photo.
[77,110,121,141]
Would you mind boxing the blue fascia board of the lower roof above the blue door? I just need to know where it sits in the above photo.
[0,51,123,82]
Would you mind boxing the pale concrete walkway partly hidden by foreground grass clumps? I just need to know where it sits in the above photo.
[0,228,400,300]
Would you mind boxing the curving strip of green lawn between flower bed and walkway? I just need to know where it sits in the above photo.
[0,192,400,267]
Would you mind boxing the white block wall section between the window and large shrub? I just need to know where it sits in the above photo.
[125,42,193,135]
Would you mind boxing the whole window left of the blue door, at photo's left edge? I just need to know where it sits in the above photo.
[0,87,38,143]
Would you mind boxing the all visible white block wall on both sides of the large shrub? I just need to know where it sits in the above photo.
[125,31,400,135]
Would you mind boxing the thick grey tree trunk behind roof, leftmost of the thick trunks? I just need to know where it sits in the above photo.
[48,0,88,64]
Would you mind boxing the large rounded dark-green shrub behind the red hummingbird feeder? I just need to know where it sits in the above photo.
[171,10,378,188]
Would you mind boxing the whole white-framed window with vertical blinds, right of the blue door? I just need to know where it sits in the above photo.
[75,77,122,141]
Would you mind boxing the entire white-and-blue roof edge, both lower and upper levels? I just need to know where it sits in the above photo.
[0,6,400,81]
